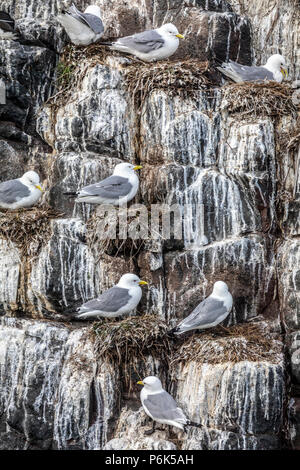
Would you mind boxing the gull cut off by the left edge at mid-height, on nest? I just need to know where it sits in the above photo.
[0,171,43,209]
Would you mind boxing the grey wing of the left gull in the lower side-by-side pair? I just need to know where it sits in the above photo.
[79,286,131,313]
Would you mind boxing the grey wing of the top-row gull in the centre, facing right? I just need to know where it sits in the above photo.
[118,29,165,54]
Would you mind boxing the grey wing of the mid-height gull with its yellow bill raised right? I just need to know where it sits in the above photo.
[79,175,132,199]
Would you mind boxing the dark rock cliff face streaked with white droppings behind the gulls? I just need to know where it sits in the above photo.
[0,0,300,449]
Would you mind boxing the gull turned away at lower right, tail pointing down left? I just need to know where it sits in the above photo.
[169,281,232,335]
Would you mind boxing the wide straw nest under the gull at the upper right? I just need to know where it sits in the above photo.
[222,81,297,117]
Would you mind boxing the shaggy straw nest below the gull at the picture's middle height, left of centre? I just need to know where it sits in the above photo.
[87,208,148,259]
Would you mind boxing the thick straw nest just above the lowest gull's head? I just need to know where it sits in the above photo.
[92,315,170,370]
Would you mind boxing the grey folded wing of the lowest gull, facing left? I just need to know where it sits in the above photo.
[143,390,187,424]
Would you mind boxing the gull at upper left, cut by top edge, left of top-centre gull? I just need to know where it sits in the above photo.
[57,3,104,46]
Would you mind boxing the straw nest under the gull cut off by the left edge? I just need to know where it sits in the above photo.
[0,207,63,257]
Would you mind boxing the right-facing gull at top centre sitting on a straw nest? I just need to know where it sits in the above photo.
[99,23,184,62]
